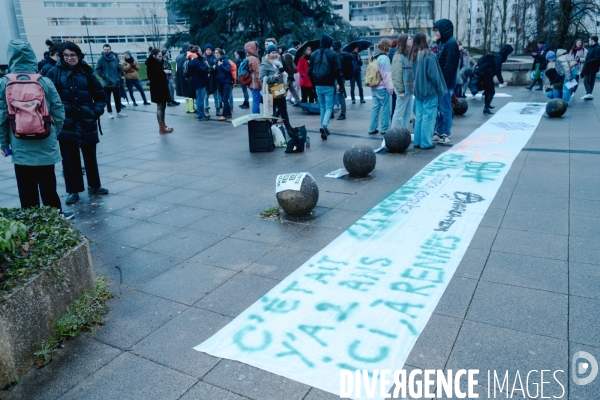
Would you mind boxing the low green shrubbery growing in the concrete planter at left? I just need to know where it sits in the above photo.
[0,207,83,296]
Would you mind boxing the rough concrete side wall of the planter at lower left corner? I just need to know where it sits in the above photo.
[0,241,95,388]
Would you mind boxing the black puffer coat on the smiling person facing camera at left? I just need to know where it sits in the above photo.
[46,60,107,146]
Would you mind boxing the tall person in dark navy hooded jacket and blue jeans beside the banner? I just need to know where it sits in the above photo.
[433,19,460,143]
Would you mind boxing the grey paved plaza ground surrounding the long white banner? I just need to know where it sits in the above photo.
[0,87,600,400]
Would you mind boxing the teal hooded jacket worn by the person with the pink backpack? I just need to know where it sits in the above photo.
[0,39,65,166]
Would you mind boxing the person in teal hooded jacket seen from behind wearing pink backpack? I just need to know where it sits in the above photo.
[0,39,73,219]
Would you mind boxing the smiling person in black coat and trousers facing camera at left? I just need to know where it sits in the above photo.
[47,42,108,204]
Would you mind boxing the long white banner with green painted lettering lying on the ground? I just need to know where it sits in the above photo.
[195,103,545,396]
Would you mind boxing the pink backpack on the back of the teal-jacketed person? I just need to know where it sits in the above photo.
[6,73,53,140]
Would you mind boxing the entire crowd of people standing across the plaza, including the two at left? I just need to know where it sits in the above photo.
[0,19,600,217]
